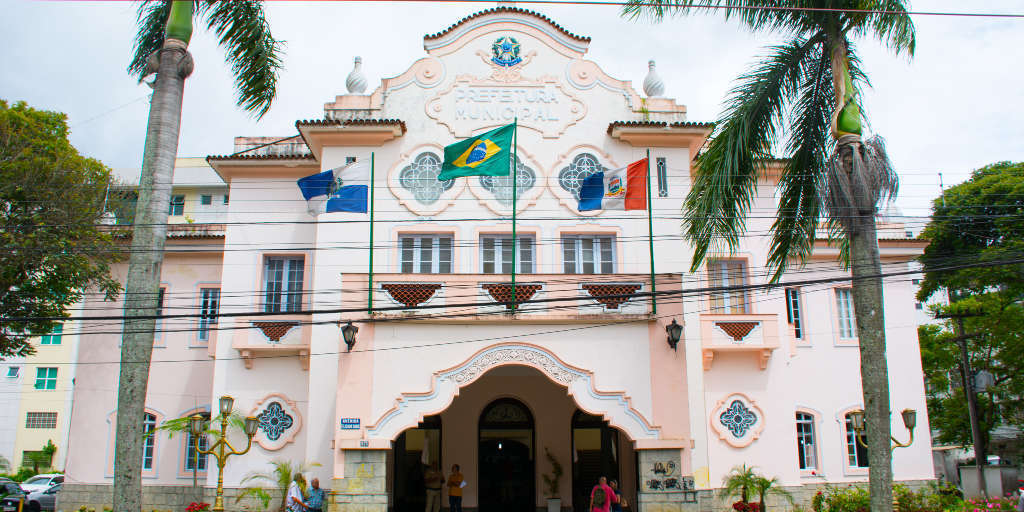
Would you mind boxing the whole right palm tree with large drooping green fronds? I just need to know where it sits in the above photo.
[624,0,915,512]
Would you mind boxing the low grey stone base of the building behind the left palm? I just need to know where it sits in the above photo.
[56,482,282,512]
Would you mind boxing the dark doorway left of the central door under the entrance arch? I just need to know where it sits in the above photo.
[392,416,442,512]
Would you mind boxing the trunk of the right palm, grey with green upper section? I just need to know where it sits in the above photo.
[830,35,893,512]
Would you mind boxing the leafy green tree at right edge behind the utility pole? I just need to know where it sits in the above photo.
[918,162,1024,464]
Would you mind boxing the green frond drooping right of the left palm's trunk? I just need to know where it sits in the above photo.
[200,0,284,119]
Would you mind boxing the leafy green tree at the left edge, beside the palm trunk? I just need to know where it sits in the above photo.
[0,99,121,357]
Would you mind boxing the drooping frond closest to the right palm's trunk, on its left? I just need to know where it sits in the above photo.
[767,37,835,283]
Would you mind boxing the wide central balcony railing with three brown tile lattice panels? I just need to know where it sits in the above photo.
[342,273,680,322]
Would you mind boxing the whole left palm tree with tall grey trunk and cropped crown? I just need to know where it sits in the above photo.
[114,0,282,510]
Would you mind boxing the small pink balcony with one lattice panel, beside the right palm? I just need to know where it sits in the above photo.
[700,314,778,371]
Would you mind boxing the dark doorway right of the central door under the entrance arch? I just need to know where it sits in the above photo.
[571,410,624,512]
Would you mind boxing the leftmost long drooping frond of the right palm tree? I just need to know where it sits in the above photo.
[684,37,821,271]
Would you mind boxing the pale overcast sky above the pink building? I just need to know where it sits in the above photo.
[0,0,1024,215]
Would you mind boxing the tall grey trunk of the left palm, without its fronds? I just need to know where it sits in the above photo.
[114,39,193,512]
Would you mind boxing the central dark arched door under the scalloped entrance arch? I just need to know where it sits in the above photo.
[477,398,537,512]
